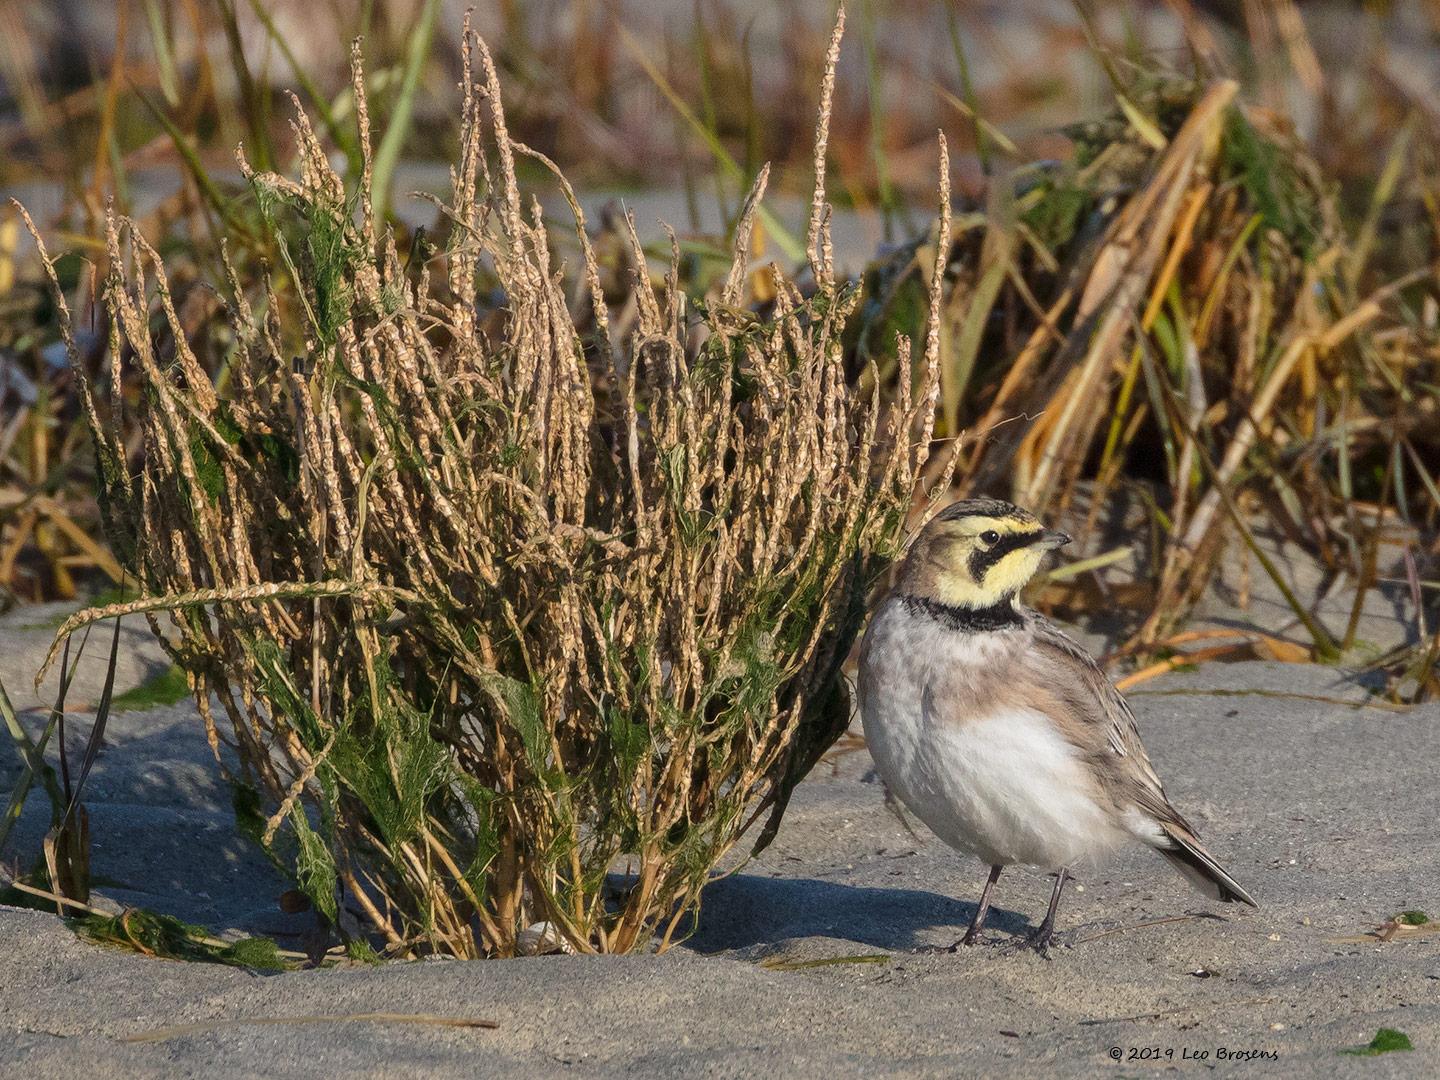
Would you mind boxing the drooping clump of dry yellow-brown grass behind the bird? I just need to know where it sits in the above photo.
[851,78,1440,688]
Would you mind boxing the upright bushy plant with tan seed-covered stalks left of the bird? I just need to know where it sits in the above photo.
[22,16,949,956]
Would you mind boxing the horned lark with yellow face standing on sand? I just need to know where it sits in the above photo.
[860,498,1256,953]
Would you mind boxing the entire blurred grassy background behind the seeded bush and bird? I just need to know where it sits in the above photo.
[0,0,1440,697]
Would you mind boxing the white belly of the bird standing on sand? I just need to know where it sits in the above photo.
[864,687,1123,870]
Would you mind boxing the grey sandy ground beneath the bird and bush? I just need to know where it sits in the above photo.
[0,584,1440,1077]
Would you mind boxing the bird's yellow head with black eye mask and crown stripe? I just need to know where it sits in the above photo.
[897,498,1070,611]
